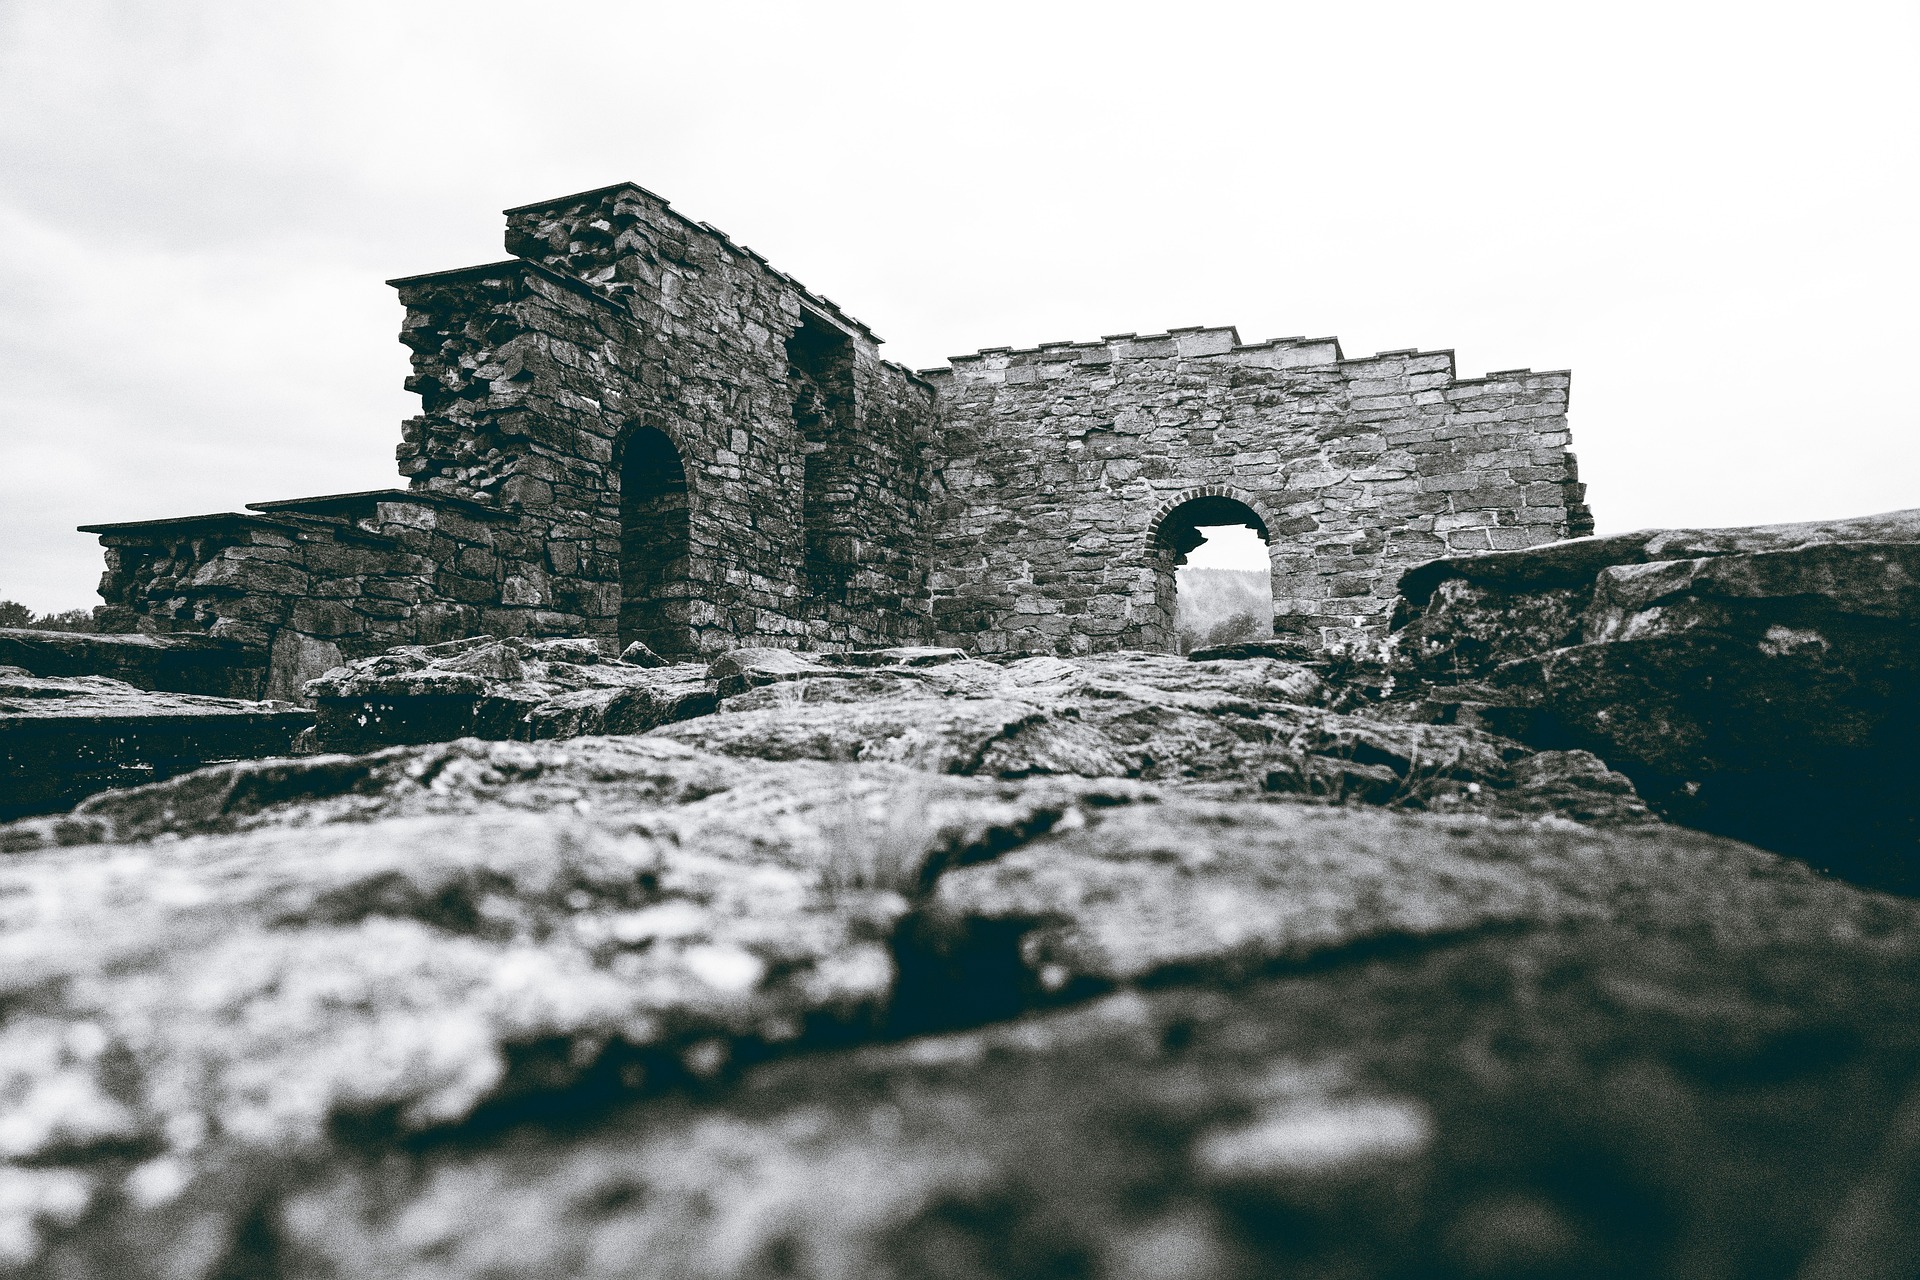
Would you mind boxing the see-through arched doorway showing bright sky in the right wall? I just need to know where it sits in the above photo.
[1148,487,1273,652]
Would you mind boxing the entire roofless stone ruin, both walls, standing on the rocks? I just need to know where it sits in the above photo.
[67,182,1592,699]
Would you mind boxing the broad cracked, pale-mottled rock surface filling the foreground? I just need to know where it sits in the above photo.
[0,625,1920,1278]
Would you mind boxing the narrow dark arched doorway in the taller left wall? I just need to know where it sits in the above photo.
[620,426,693,658]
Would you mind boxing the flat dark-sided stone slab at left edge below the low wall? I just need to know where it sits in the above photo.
[0,666,313,818]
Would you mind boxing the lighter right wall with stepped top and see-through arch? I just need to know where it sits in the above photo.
[927,328,1592,652]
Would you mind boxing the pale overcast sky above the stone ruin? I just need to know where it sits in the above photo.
[0,0,1920,610]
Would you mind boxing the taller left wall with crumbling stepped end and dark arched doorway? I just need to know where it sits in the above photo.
[86,184,933,697]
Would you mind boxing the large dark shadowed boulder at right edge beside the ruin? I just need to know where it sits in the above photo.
[1400,510,1920,892]
